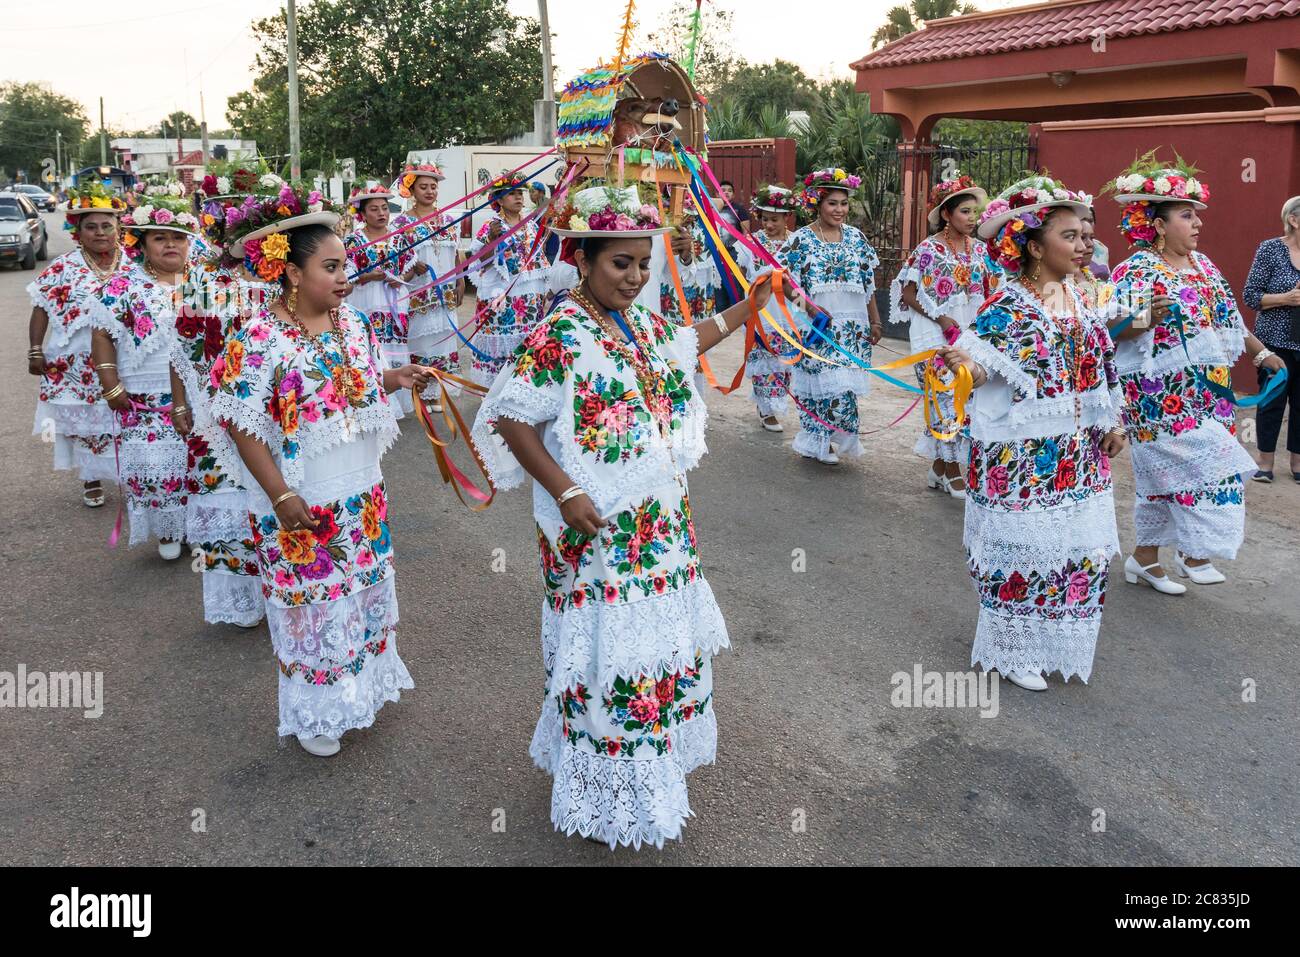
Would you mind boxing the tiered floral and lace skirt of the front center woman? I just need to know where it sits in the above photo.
[529,482,728,848]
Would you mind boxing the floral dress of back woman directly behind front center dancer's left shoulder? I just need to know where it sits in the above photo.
[469,215,551,385]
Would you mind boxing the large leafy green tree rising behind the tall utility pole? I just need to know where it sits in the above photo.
[226,0,542,177]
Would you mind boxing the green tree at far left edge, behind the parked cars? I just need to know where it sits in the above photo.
[0,83,90,182]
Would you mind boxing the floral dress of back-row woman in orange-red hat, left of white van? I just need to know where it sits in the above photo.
[393,213,460,387]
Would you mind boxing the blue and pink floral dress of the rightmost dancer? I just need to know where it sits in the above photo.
[1112,250,1256,558]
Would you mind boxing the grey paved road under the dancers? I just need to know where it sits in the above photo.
[0,216,1300,865]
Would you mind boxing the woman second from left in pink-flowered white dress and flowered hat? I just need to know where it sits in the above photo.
[91,196,198,560]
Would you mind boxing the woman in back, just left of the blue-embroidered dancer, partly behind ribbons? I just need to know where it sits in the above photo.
[736,185,800,432]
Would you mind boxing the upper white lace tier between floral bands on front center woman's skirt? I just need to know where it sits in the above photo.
[542,577,731,697]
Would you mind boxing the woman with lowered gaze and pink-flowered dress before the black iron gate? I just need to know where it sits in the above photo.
[889,176,997,498]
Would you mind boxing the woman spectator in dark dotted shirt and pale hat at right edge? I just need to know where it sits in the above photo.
[1242,196,1300,482]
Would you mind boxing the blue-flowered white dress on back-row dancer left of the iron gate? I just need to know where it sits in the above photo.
[780,224,880,456]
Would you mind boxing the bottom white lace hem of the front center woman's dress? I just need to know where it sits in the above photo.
[529,702,718,850]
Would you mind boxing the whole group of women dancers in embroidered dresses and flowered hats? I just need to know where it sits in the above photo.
[29,156,1300,846]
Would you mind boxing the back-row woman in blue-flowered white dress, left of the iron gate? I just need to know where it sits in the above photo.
[780,169,883,465]
